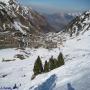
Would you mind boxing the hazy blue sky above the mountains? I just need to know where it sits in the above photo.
[19,0,90,12]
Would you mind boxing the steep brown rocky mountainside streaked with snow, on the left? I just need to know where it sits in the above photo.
[0,0,53,47]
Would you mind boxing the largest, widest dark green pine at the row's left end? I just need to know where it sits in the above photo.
[33,56,43,75]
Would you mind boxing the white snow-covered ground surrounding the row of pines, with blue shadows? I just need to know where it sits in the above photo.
[0,22,90,90]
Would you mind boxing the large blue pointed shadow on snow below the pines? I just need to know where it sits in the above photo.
[35,74,56,90]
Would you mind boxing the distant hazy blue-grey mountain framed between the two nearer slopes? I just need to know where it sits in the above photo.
[43,12,76,32]
